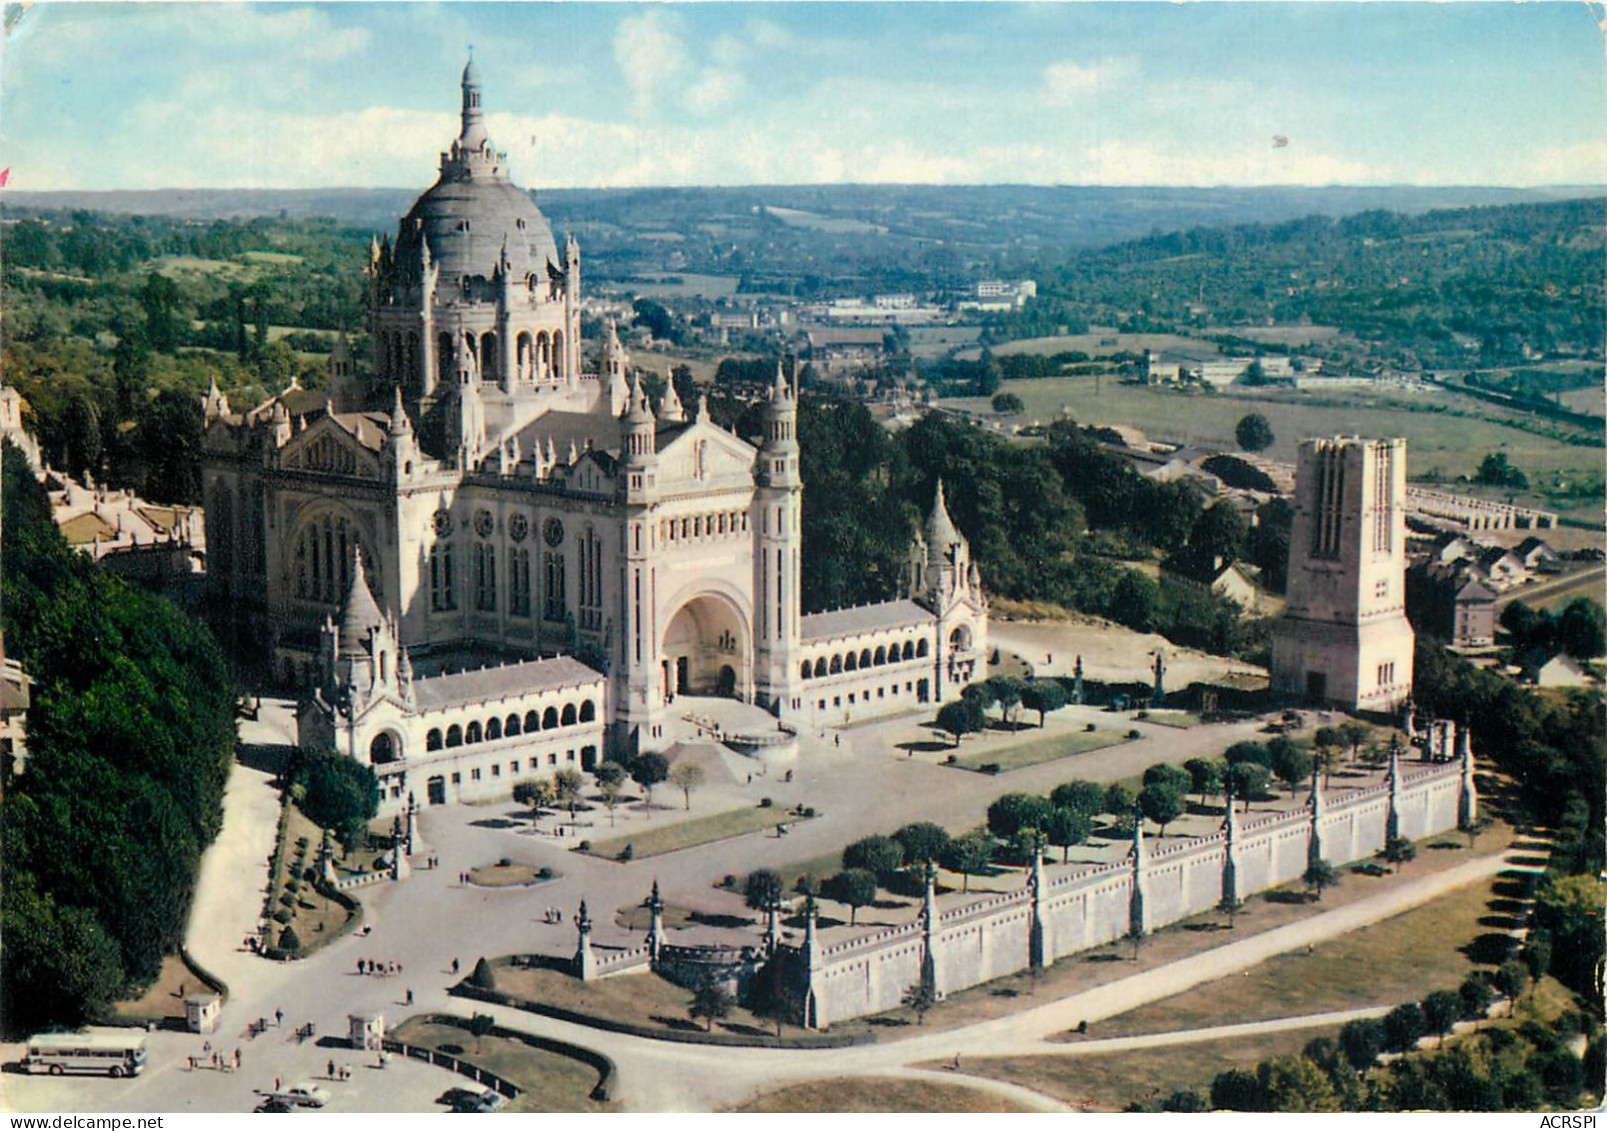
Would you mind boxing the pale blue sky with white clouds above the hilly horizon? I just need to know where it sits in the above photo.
[0,0,1607,190]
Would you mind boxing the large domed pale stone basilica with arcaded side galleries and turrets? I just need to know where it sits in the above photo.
[202,61,988,810]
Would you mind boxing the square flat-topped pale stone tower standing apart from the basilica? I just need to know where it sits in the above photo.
[1273,437,1416,712]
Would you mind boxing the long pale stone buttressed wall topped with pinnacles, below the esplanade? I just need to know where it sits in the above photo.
[797,741,1477,1028]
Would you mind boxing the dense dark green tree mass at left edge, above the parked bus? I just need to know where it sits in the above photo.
[0,443,235,1033]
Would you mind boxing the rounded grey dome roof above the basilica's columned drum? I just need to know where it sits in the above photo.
[397,170,562,288]
